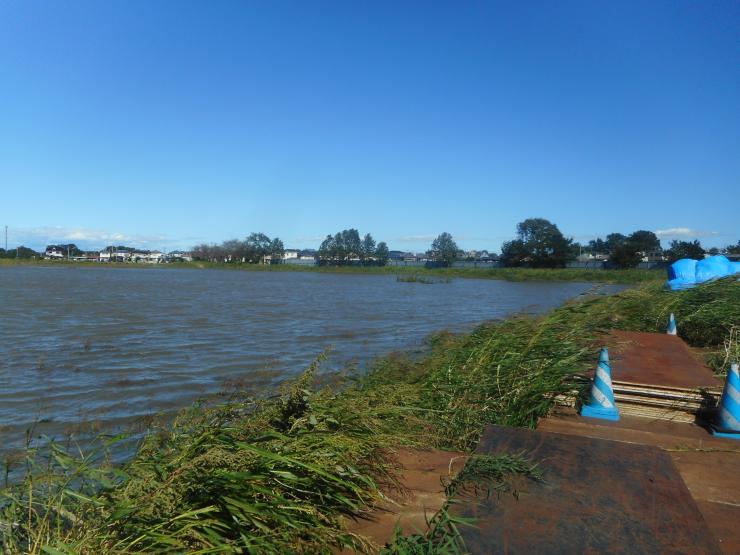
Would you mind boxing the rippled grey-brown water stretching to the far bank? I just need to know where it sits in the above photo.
[0,266,621,450]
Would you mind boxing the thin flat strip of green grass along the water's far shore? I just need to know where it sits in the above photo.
[0,259,666,284]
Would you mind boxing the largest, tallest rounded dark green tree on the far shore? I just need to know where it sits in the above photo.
[501,218,574,268]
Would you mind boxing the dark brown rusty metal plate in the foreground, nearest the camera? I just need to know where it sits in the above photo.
[453,426,721,555]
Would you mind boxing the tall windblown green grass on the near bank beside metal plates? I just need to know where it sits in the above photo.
[0,279,740,554]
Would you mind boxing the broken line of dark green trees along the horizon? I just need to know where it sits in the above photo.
[0,218,740,268]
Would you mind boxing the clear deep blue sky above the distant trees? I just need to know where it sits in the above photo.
[0,0,740,250]
